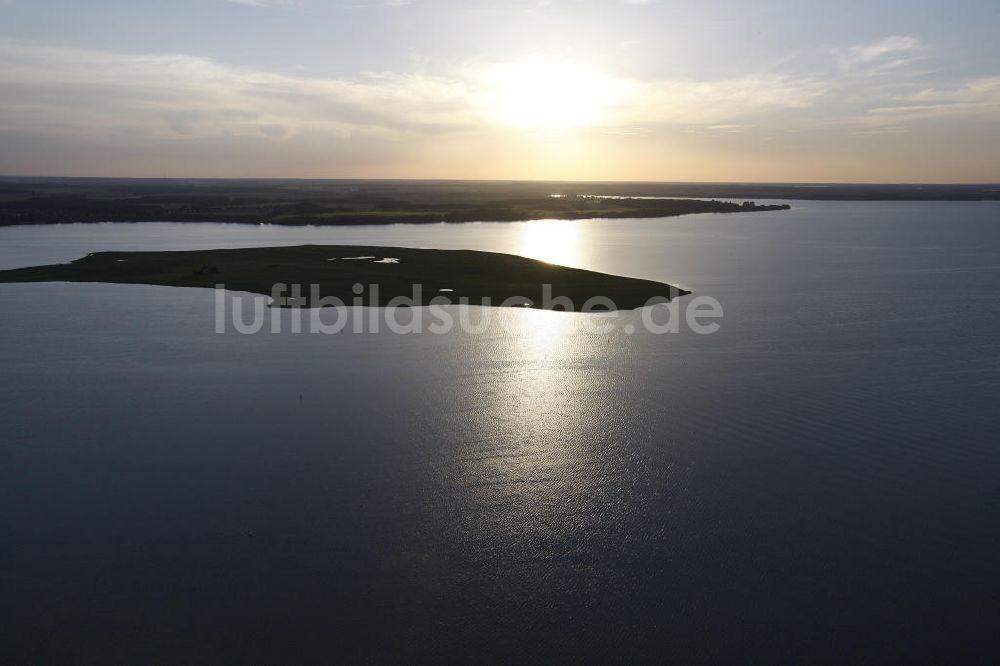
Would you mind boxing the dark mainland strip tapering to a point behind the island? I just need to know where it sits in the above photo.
[0,178,804,226]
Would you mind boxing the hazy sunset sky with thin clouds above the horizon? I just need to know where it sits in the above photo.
[0,0,1000,183]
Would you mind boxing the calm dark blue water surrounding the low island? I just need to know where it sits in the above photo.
[0,202,1000,664]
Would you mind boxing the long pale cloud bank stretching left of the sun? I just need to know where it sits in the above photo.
[0,41,474,137]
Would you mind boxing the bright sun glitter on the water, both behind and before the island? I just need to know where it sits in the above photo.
[414,220,615,548]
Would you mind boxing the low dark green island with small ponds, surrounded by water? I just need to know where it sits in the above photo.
[0,245,690,311]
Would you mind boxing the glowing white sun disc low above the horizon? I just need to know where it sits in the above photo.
[479,57,621,129]
